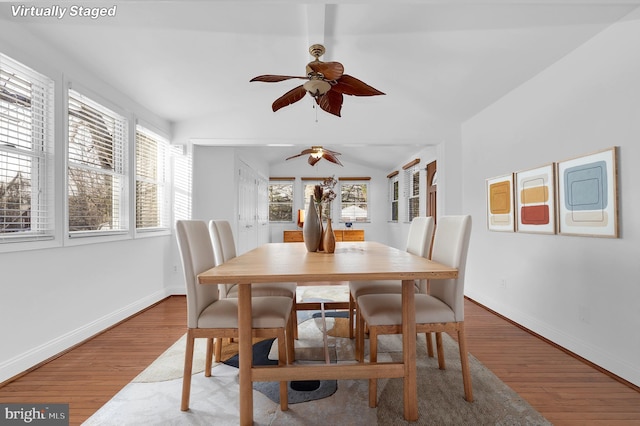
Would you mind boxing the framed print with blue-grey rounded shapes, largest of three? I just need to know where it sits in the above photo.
[556,147,618,238]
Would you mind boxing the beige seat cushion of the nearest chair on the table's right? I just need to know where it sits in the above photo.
[358,294,455,326]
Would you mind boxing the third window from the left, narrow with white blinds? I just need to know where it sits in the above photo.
[136,126,169,230]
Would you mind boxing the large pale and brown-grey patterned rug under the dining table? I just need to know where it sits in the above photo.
[85,317,550,426]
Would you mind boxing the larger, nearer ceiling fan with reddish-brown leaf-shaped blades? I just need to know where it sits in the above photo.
[251,44,384,117]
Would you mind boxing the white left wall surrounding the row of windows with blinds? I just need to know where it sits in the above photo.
[0,21,177,382]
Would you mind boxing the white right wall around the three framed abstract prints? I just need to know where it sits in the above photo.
[461,10,640,385]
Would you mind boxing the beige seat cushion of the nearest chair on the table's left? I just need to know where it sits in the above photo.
[198,296,293,328]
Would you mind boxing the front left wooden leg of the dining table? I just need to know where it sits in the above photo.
[238,284,253,425]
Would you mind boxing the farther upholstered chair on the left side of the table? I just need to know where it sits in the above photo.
[209,220,298,342]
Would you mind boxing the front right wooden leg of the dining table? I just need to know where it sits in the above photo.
[402,280,418,422]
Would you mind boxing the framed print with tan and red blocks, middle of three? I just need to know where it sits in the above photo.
[514,163,556,234]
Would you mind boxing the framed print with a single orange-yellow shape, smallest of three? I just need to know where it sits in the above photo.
[487,173,514,232]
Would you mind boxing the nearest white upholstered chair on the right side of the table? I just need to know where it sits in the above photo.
[356,216,473,407]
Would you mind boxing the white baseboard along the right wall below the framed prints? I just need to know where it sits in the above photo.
[465,293,640,390]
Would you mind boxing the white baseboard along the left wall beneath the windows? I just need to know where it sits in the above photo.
[0,289,172,387]
